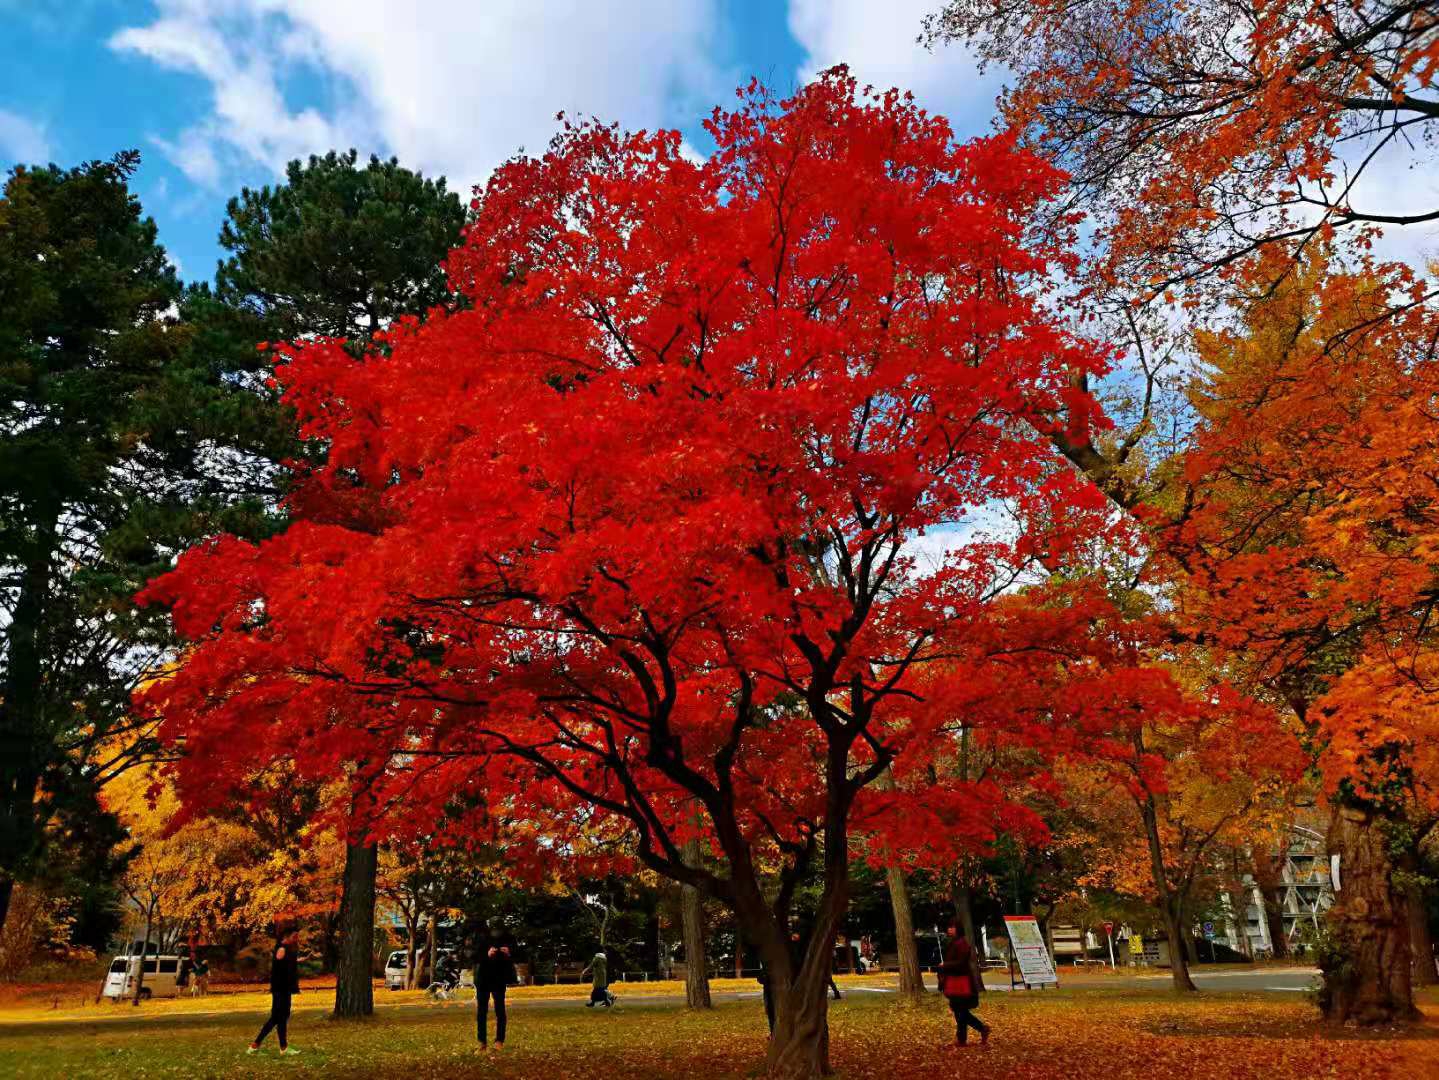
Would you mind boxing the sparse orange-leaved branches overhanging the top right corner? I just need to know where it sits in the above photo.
[927,0,1439,296]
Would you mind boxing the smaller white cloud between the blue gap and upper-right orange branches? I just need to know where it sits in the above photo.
[789,0,1003,137]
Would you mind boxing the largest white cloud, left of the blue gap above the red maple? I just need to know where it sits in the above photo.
[111,0,734,187]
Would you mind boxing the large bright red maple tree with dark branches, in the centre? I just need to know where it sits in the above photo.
[141,72,1133,1077]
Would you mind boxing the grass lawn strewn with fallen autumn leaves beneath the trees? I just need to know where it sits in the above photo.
[0,984,1439,1080]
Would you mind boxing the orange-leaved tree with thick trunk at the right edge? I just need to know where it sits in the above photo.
[1167,250,1439,1022]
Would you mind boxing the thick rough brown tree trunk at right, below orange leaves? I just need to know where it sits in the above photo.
[1320,802,1417,1025]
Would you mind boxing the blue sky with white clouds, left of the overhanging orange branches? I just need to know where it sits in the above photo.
[0,0,997,280]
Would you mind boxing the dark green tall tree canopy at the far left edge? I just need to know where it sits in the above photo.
[0,152,282,919]
